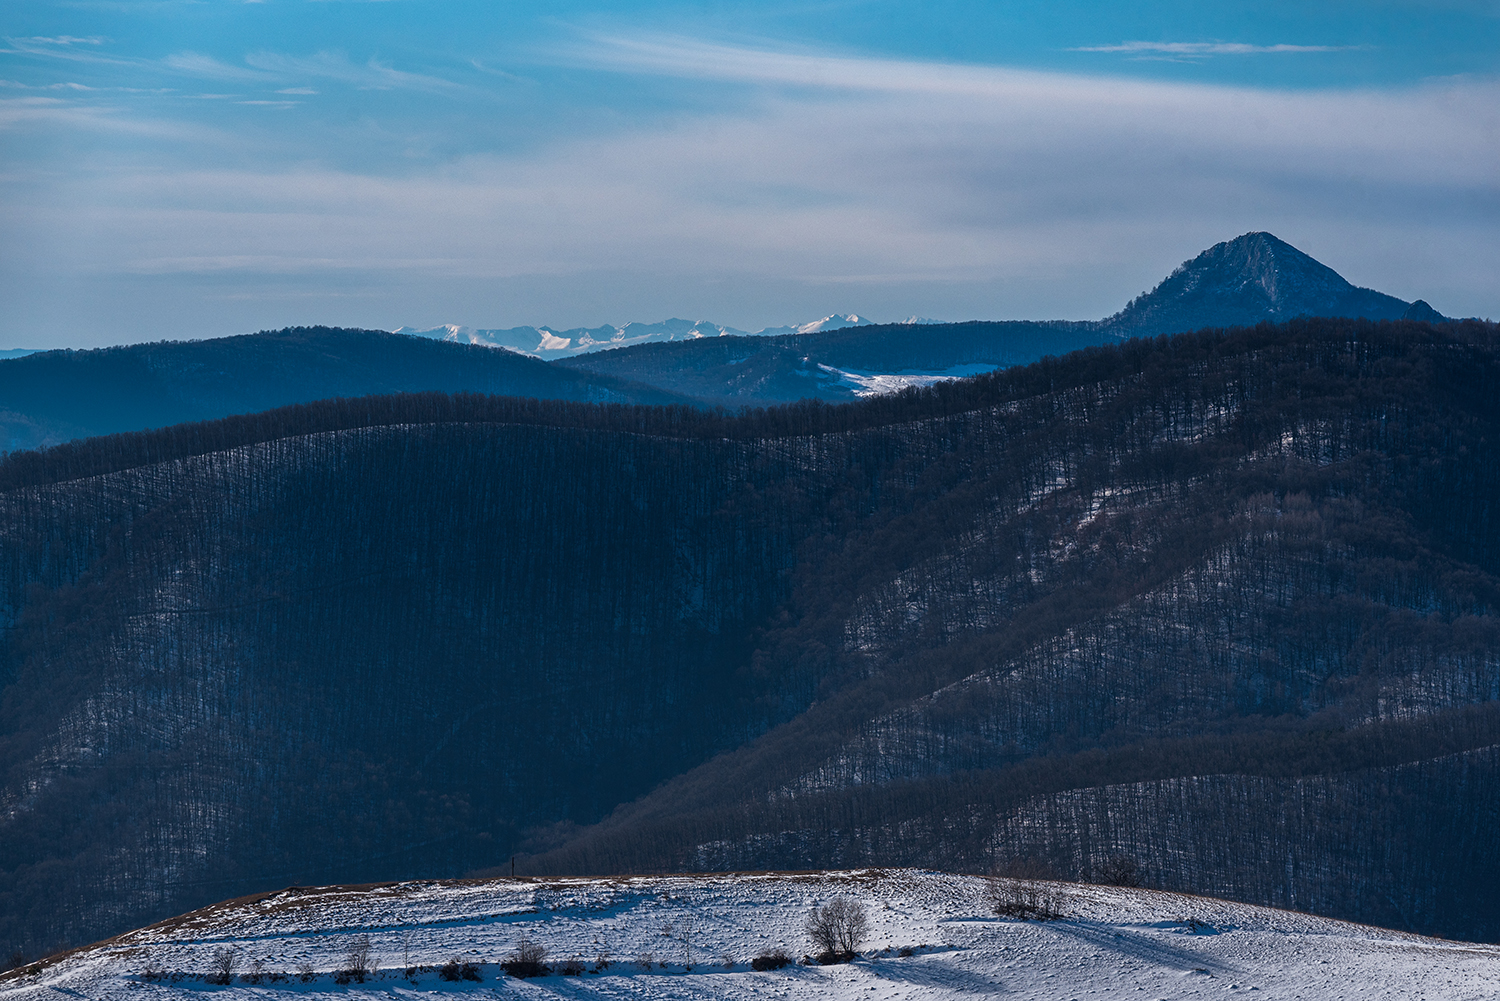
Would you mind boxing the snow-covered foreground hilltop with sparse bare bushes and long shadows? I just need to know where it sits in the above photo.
[0,869,1500,1001]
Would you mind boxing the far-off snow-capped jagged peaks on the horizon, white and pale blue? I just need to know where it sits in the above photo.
[392,312,900,359]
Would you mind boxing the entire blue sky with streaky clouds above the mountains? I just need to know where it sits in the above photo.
[0,0,1500,348]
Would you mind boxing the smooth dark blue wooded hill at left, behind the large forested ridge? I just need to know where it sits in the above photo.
[0,327,683,452]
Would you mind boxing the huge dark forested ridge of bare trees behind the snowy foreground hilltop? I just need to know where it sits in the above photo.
[0,320,1500,953]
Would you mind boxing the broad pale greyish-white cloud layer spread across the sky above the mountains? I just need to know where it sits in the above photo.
[0,35,1500,336]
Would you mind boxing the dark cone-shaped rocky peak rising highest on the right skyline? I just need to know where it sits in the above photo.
[1103,233,1443,338]
